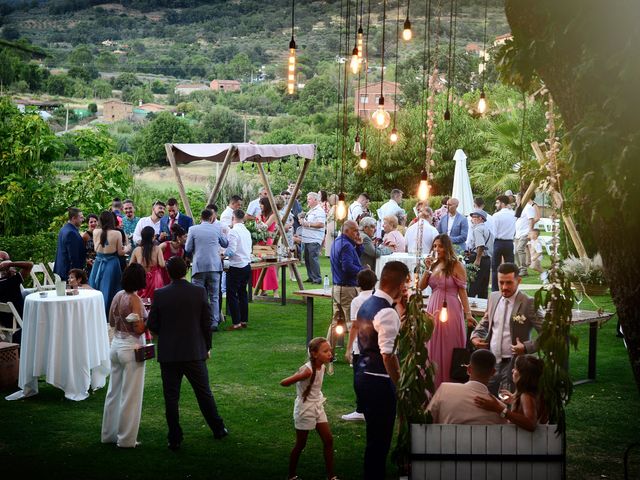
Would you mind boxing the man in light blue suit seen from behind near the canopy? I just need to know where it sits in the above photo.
[185,210,229,332]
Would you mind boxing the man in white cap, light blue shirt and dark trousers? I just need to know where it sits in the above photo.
[468,208,493,298]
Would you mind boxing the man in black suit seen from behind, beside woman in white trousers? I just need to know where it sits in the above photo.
[147,257,229,451]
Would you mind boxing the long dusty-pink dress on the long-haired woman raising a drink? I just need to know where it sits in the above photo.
[427,275,467,388]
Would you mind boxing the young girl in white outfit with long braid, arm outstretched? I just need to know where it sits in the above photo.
[280,337,338,480]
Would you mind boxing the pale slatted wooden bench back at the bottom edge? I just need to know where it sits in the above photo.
[411,424,565,480]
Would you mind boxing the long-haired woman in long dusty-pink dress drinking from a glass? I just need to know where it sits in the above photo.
[420,233,474,388]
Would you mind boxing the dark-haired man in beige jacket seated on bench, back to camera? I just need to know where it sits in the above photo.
[427,350,507,425]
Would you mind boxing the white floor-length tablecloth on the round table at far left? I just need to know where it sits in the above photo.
[6,289,111,401]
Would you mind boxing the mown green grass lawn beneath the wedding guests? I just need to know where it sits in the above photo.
[0,260,640,480]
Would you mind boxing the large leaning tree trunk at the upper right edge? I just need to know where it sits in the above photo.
[506,0,640,390]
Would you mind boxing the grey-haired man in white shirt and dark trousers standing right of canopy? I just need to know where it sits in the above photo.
[300,192,327,285]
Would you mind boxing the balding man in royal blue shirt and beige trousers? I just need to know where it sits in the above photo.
[329,220,363,347]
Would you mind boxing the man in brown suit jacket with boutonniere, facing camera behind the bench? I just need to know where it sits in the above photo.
[471,263,542,396]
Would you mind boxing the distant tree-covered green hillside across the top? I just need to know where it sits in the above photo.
[0,0,508,80]
